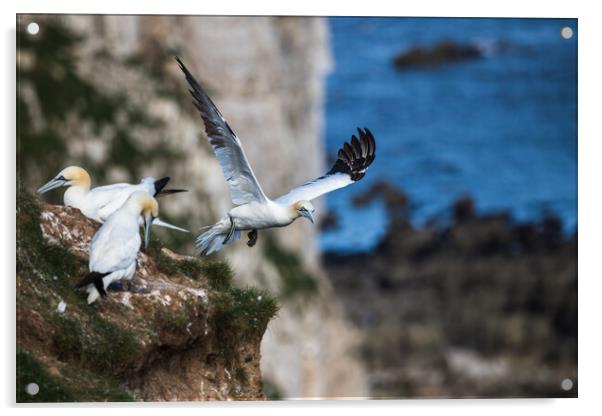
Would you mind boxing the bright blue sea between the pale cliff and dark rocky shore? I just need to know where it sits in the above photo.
[320,17,577,251]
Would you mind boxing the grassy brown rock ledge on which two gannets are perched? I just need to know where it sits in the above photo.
[17,187,277,401]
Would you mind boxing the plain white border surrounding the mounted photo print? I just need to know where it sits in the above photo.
[0,0,602,416]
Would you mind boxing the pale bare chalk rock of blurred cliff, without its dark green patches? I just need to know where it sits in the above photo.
[25,16,368,397]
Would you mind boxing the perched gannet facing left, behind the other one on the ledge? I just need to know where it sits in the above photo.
[38,166,188,232]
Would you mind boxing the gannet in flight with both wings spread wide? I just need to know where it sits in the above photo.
[176,58,376,255]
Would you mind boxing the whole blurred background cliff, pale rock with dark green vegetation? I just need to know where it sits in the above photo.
[18,15,368,397]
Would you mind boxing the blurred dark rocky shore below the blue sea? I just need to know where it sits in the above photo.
[325,183,577,398]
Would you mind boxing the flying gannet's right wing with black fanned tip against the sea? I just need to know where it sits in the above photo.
[276,128,376,205]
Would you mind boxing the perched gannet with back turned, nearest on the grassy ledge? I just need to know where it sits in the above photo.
[77,191,159,303]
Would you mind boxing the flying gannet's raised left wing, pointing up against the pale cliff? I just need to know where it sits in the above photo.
[176,57,267,205]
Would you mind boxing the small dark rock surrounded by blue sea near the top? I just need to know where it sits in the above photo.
[393,41,482,69]
